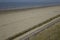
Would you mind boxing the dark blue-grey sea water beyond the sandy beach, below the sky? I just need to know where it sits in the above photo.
[0,2,60,10]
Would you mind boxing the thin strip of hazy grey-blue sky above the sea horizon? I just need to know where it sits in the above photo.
[0,0,60,2]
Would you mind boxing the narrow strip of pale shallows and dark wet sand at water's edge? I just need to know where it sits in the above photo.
[0,5,60,12]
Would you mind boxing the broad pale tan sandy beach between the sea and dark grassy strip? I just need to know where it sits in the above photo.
[0,6,60,40]
